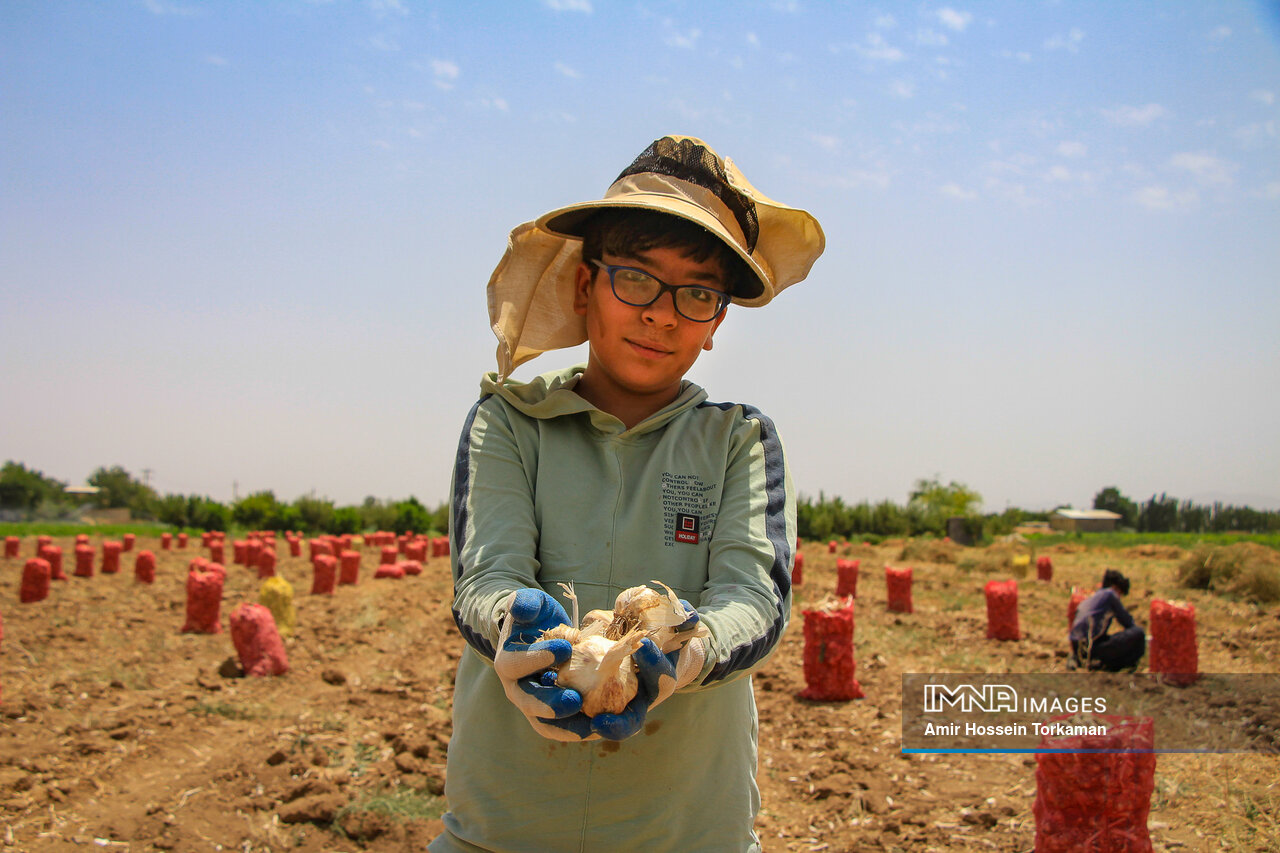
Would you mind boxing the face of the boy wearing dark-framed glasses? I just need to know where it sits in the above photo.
[573,242,724,411]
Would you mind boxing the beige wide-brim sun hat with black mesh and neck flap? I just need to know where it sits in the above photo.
[488,136,826,382]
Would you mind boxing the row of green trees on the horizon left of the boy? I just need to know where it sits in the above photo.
[0,460,449,535]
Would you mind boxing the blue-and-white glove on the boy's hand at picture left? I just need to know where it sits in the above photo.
[493,588,591,742]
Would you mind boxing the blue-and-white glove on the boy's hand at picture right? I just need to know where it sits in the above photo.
[591,599,707,740]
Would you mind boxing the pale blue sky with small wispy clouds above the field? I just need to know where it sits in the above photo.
[0,0,1280,510]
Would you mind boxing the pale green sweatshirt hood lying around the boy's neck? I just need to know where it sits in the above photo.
[480,364,707,435]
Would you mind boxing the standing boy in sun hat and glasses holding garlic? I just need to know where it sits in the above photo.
[430,137,824,852]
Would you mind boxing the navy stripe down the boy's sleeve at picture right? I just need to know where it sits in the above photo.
[699,402,792,684]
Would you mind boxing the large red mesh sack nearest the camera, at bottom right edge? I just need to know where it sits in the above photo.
[1032,715,1156,853]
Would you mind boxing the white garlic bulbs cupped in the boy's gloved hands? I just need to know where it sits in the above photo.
[540,580,709,717]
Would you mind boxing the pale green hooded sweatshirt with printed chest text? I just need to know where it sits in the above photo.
[431,366,796,852]
